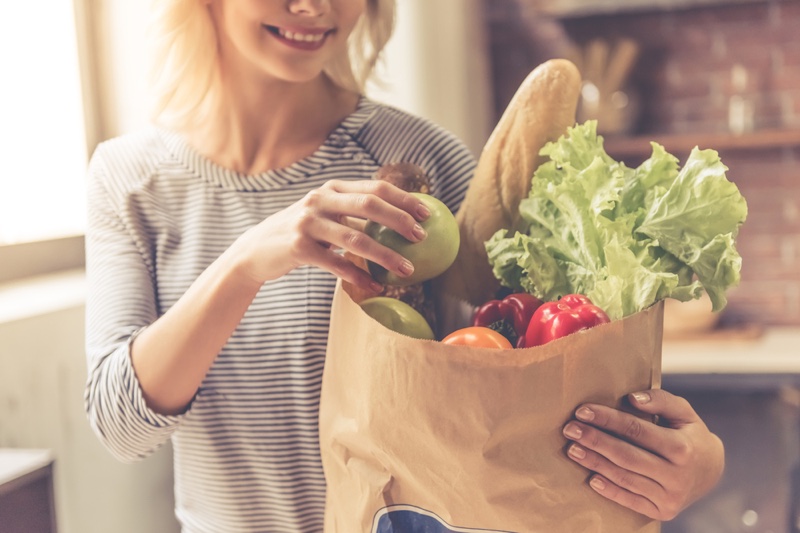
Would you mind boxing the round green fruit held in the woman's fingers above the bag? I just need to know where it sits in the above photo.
[364,193,461,286]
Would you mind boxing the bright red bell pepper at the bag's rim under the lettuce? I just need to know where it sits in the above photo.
[524,294,610,346]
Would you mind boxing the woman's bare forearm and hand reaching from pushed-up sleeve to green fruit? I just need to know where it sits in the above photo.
[131,181,429,414]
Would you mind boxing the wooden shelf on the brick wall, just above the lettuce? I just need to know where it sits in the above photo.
[604,129,800,159]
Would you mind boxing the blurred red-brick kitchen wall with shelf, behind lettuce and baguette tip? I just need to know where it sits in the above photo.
[485,0,800,325]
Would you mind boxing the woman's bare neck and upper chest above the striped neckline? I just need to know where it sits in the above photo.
[189,71,358,174]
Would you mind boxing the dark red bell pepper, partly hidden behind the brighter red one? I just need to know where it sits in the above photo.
[472,292,542,346]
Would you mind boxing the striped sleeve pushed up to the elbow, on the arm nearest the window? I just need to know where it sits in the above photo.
[85,144,180,462]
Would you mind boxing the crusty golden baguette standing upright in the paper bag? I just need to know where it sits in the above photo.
[436,59,581,306]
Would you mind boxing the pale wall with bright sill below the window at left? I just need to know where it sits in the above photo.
[0,274,178,533]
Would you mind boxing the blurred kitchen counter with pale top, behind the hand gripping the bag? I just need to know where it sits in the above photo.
[662,328,800,533]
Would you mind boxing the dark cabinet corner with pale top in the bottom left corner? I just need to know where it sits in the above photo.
[0,449,56,533]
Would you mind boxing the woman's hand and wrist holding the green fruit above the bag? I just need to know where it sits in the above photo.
[232,180,430,290]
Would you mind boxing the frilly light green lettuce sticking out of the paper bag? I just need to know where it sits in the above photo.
[486,121,747,319]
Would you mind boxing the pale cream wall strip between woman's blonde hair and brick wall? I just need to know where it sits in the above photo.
[368,0,493,156]
